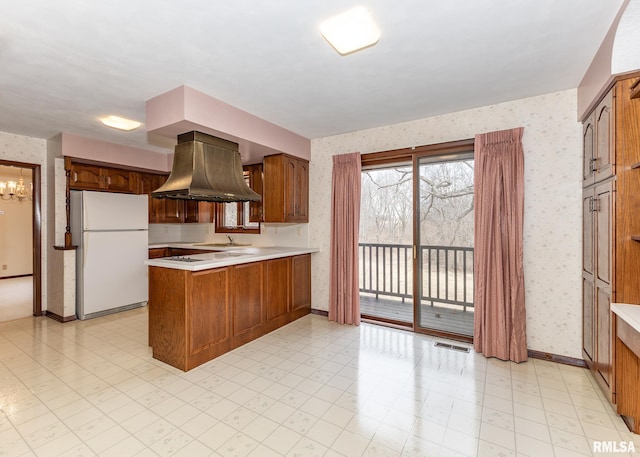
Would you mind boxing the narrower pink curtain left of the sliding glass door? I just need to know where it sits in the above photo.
[329,152,361,325]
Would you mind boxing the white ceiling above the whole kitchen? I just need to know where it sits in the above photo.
[0,0,623,152]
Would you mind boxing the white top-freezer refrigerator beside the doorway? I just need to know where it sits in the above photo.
[71,190,149,319]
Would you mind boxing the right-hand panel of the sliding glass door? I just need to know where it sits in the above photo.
[414,152,474,337]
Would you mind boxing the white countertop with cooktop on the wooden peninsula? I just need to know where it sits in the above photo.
[144,243,319,271]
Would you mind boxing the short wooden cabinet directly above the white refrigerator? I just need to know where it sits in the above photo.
[69,163,139,194]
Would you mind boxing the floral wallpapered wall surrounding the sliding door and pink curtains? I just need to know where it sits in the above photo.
[309,90,582,358]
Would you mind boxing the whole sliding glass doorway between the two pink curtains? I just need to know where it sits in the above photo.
[359,140,474,341]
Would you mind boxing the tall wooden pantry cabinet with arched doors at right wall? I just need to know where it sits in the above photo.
[582,78,640,403]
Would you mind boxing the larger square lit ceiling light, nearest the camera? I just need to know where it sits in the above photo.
[320,6,380,56]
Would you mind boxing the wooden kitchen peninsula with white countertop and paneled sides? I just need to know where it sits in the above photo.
[145,244,318,371]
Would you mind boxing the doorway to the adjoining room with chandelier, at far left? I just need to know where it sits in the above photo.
[0,160,42,322]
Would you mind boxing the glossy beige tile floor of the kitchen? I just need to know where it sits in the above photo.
[0,308,640,457]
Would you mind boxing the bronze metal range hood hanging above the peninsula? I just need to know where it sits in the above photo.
[151,131,261,202]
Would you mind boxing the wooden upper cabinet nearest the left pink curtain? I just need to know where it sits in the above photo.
[263,154,309,222]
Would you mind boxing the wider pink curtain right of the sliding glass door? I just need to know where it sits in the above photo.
[474,127,527,362]
